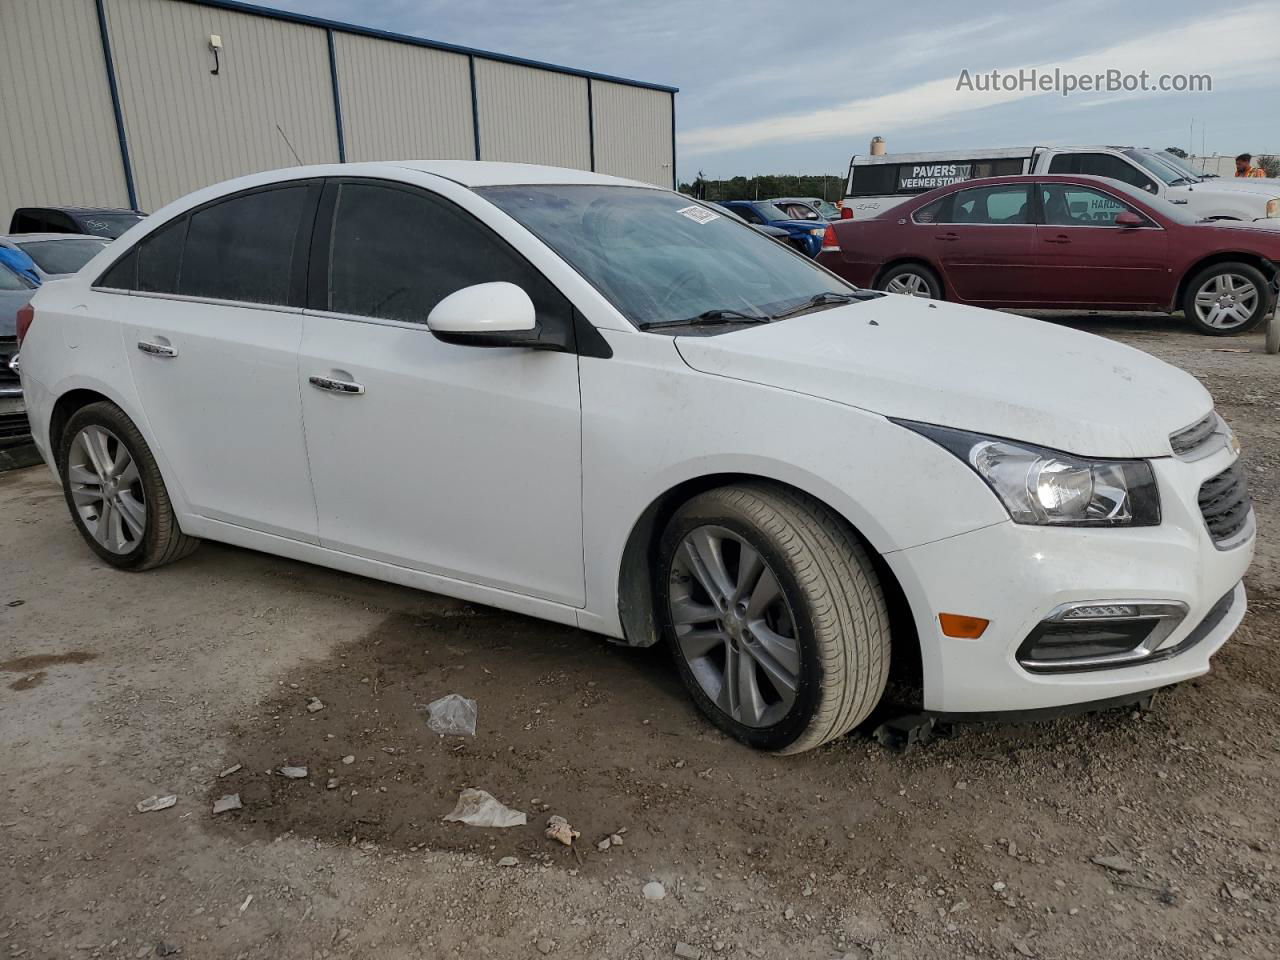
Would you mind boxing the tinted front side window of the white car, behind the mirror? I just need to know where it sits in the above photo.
[324,183,571,329]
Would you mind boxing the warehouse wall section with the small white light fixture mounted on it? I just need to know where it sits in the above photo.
[103,0,338,210]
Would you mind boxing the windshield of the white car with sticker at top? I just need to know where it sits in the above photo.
[476,184,854,329]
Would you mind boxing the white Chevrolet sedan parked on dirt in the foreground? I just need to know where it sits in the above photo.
[19,161,1254,753]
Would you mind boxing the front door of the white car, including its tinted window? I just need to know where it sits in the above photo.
[298,180,585,605]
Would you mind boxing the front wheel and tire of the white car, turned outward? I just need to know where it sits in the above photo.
[657,484,890,754]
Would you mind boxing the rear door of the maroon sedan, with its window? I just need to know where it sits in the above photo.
[920,182,1036,303]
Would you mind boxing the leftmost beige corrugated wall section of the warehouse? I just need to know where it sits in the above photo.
[0,0,128,225]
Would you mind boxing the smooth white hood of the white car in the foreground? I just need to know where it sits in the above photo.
[676,294,1213,457]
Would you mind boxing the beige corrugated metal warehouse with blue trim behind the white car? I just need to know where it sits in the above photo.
[0,0,676,221]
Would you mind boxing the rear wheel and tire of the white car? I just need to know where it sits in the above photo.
[58,401,200,570]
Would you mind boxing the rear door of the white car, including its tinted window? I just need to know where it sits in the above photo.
[117,184,320,541]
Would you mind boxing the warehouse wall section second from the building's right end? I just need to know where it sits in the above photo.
[476,58,591,170]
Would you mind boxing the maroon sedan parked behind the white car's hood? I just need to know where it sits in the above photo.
[818,175,1280,335]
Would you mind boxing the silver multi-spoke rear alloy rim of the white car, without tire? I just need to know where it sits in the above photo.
[67,425,147,554]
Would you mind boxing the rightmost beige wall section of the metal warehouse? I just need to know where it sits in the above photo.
[591,79,675,187]
